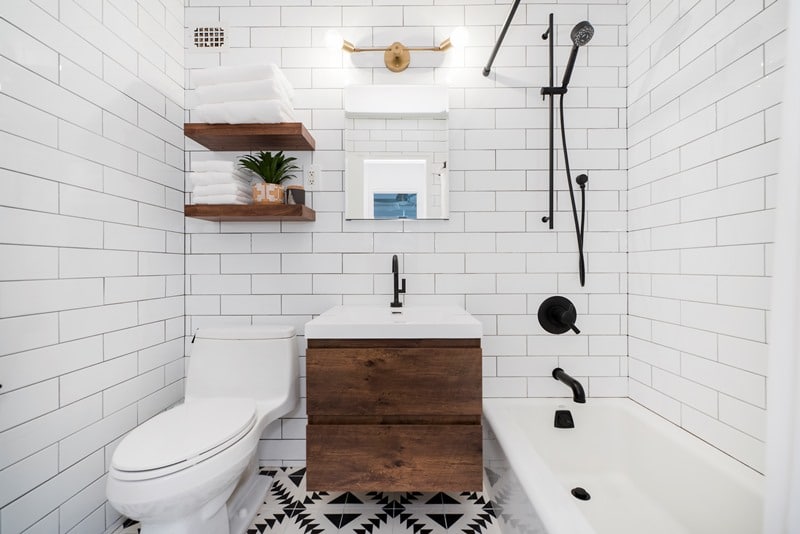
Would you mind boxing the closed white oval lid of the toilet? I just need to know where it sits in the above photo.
[111,399,255,471]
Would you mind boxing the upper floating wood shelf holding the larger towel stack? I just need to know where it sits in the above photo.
[183,122,316,151]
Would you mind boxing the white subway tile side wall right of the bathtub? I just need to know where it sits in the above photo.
[628,0,787,471]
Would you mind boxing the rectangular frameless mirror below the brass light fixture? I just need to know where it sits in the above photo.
[344,86,450,219]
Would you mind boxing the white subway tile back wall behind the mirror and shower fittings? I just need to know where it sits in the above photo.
[184,0,628,464]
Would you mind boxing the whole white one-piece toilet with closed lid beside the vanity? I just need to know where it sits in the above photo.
[106,326,299,534]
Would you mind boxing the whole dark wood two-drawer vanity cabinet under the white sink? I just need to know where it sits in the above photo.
[306,339,483,491]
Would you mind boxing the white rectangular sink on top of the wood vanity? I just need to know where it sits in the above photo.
[305,306,483,339]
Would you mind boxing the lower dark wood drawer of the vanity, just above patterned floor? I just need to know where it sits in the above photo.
[306,424,483,492]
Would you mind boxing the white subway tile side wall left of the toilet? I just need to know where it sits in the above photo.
[0,0,185,534]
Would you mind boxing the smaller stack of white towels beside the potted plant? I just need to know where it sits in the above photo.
[189,160,253,204]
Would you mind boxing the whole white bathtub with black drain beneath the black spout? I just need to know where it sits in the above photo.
[483,398,763,534]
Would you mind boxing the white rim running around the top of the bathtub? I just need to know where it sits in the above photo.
[483,397,764,534]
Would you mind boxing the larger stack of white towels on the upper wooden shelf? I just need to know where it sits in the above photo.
[192,64,297,124]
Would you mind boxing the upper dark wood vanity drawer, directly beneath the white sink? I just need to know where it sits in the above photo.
[306,346,482,416]
